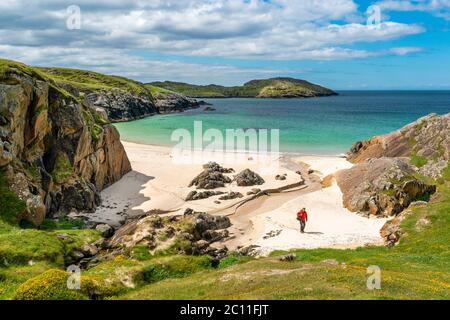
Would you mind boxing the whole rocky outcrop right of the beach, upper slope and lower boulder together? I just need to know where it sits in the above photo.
[335,114,450,218]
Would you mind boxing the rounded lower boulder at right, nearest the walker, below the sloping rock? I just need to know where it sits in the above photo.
[335,158,436,217]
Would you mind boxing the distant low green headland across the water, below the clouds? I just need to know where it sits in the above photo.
[150,78,337,98]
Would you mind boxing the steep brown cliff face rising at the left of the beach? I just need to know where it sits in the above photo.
[0,63,131,225]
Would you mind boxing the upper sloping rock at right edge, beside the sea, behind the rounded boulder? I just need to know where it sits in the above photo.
[347,114,450,178]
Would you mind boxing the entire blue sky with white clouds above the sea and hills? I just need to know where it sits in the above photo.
[0,0,450,90]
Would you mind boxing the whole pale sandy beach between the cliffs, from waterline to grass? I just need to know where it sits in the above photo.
[82,142,386,255]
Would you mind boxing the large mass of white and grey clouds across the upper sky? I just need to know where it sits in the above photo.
[0,0,428,81]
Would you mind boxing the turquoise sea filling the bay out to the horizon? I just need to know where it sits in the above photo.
[116,91,450,155]
